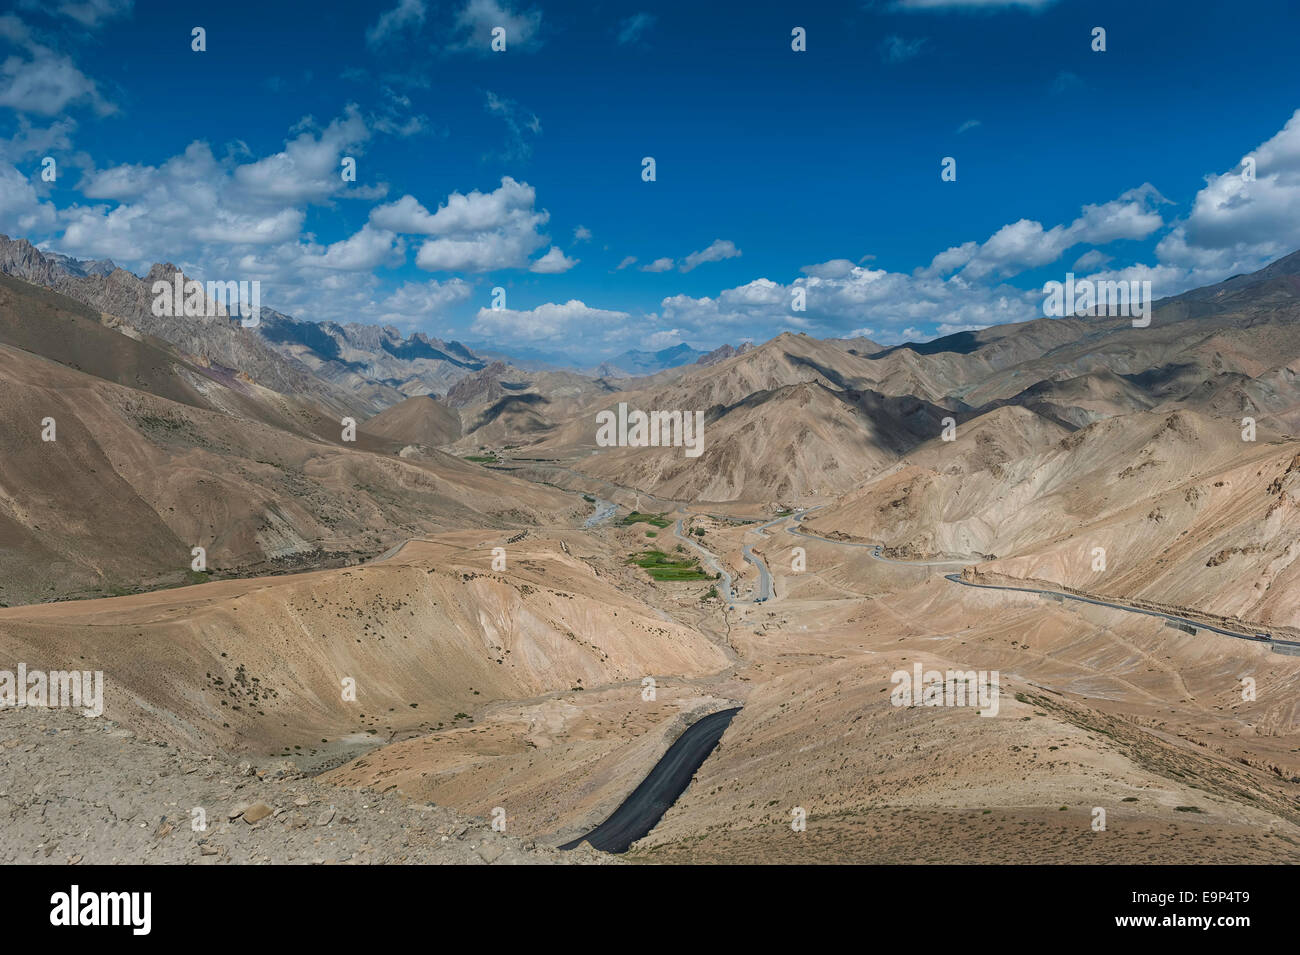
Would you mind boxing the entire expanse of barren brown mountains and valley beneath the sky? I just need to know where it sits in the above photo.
[0,233,1300,863]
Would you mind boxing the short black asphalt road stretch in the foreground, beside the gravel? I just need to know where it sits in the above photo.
[560,707,740,852]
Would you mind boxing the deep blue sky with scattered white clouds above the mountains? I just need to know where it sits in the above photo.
[0,0,1300,364]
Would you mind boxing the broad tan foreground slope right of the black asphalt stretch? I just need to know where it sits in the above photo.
[632,561,1300,863]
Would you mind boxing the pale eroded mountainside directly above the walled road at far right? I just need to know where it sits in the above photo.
[807,408,1300,628]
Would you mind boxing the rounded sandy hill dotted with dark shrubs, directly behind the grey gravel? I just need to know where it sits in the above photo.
[0,531,727,763]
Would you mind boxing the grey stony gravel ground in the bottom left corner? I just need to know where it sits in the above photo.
[0,708,618,865]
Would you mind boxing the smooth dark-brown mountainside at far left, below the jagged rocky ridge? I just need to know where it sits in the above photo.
[0,272,573,604]
